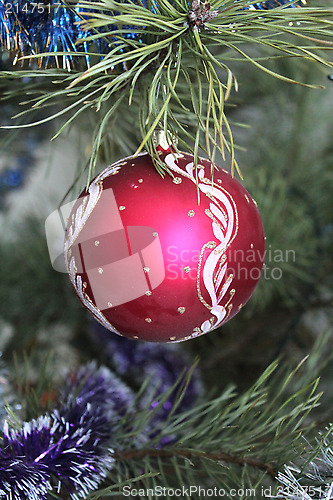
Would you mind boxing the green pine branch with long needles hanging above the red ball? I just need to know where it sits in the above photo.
[3,0,333,181]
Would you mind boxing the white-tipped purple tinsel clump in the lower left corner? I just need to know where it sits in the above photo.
[0,363,133,500]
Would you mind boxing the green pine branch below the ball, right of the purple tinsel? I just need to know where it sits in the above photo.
[96,358,322,498]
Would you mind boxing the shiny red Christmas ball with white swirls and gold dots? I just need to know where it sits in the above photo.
[65,152,265,342]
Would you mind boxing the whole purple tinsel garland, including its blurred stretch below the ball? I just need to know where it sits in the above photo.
[0,346,202,500]
